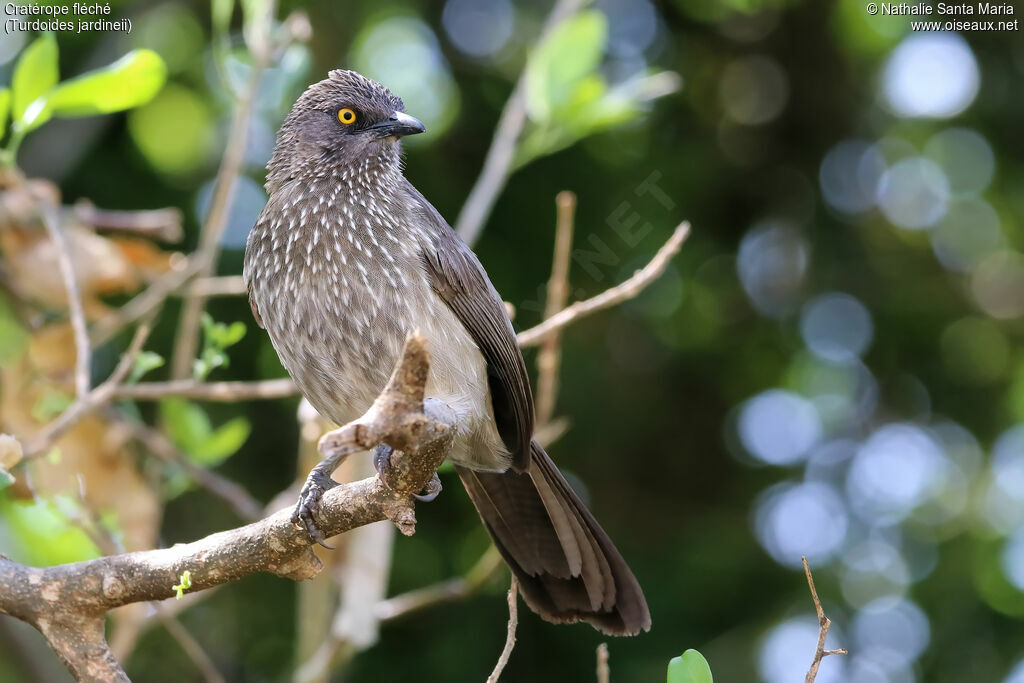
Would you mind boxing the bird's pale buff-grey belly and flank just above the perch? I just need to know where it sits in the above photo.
[260,274,511,471]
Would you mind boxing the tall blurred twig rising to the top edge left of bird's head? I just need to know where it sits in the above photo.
[171,10,275,379]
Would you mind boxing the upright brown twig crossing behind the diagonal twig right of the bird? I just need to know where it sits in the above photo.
[536,191,577,425]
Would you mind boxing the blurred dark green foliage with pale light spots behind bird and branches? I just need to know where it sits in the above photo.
[0,0,1024,682]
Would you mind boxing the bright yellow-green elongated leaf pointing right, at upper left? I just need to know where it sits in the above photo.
[46,50,167,117]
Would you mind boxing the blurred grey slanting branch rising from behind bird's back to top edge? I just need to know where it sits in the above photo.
[455,0,584,245]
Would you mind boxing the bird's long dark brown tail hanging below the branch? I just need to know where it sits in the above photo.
[456,441,650,636]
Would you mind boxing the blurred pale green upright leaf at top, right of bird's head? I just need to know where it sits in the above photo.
[526,10,608,123]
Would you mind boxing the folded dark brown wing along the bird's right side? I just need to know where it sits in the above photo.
[408,184,534,471]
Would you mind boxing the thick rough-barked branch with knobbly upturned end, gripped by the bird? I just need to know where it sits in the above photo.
[0,333,455,681]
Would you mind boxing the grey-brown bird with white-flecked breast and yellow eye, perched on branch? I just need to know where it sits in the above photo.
[243,70,650,636]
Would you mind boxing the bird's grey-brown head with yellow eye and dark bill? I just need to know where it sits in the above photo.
[267,70,425,193]
